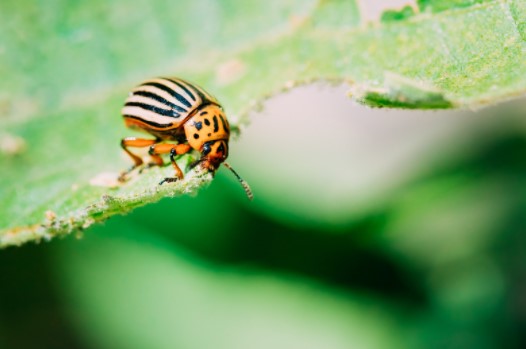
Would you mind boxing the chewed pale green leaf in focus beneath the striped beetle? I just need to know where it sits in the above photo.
[0,0,526,246]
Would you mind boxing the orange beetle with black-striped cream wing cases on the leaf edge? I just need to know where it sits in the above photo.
[119,77,253,200]
